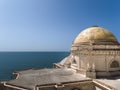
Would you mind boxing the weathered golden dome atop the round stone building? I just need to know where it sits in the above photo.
[73,26,118,45]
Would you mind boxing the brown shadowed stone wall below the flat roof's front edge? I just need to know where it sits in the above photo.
[37,81,93,90]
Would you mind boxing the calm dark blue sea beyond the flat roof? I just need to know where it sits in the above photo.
[0,52,69,80]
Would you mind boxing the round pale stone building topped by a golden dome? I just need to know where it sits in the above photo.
[55,26,120,78]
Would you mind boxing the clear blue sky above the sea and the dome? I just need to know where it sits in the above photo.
[0,0,120,51]
